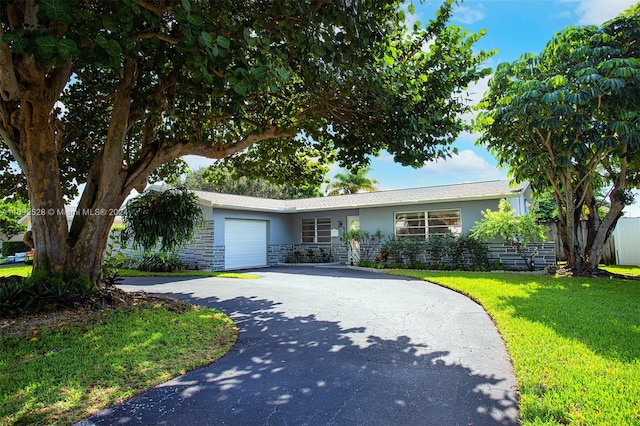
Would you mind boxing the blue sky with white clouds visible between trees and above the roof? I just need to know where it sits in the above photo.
[181,0,640,216]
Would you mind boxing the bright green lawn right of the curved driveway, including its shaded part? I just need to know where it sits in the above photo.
[384,270,640,425]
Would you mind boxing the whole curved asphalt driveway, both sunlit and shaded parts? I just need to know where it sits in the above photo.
[81,267,518,425]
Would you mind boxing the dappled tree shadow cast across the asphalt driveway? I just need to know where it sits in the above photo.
[81,293,517,425]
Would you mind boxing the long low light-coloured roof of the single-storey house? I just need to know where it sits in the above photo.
[194,180,528,213]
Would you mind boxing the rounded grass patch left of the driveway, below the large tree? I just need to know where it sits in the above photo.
[0,303,237,424]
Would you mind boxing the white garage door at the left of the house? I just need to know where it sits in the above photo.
[224,219,267,269]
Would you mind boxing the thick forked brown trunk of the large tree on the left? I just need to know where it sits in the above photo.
[19,98,130,284]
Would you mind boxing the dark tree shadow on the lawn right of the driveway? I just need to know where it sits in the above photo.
[503,278,640,362]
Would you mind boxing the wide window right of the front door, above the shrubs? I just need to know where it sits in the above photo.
[395,209,462,238]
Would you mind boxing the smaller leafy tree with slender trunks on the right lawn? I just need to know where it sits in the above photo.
[478,5,640,272]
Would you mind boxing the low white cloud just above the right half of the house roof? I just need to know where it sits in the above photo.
[422,149,505,182]
